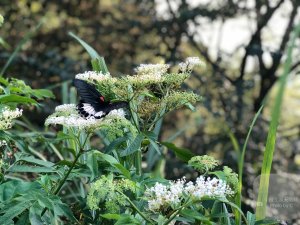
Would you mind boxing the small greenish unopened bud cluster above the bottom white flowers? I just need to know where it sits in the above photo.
[188,155,219,173]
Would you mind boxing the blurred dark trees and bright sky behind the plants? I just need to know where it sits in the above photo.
[0,0,300,221]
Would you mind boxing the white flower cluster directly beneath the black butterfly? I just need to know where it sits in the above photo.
[45,104,125,130]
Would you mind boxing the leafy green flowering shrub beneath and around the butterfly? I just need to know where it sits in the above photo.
[0,13,292,225]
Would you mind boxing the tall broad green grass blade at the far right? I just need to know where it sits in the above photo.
[256,24,300,220]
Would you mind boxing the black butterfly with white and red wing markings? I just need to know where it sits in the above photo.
[73,79,128,119]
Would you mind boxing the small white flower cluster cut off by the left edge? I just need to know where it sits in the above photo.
[0,107,23,130]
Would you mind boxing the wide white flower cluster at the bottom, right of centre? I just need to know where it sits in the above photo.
[145,176,233,212]
